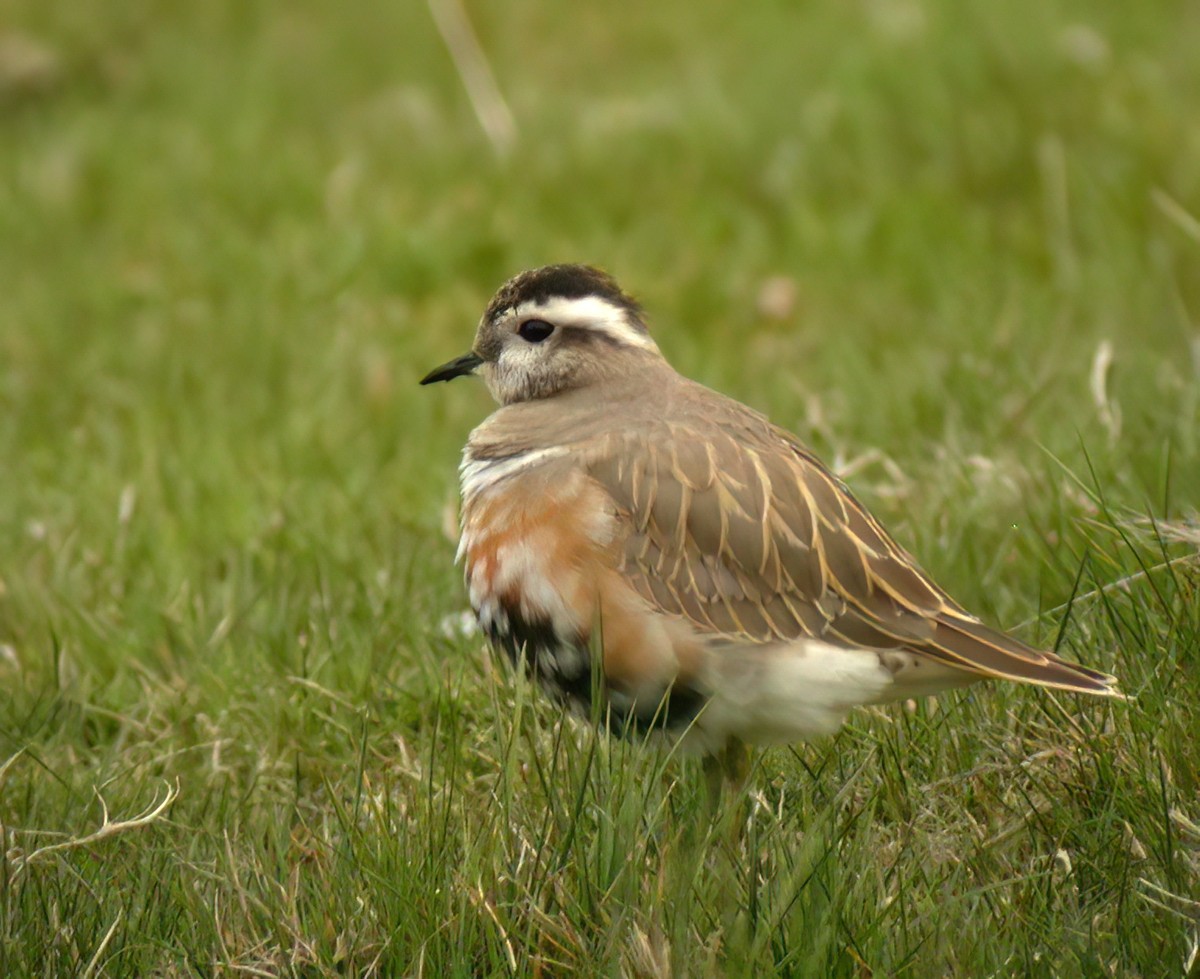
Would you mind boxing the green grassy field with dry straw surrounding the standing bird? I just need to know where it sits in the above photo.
[0,0,1200,979]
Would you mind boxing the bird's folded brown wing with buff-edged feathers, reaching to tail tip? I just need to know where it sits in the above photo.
[581,412,1115,693]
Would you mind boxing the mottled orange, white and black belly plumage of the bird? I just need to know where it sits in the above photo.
[461,473,704,728]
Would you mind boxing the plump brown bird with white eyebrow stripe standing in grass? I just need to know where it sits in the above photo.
[420,264,1122,780]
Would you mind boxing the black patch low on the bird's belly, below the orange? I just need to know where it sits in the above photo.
[480,608,708,733]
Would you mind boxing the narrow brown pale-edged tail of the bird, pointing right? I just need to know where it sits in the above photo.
[919,615,1128,699]
